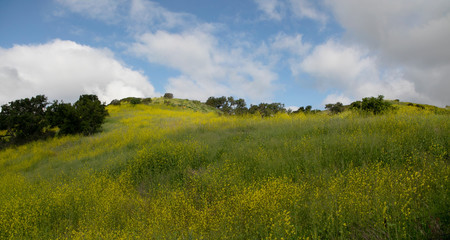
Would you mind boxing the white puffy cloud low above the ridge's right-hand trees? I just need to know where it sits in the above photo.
[292,40,428,103]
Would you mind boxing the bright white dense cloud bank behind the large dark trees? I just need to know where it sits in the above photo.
[0,40,156,103]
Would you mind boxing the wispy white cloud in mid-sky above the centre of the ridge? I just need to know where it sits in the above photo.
[130,29,277,101]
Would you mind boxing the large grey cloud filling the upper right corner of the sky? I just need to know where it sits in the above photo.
[326,0,450,105]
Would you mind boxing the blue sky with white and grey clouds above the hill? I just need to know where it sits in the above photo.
[0,0,450,109]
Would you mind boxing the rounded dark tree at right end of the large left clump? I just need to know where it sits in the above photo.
[74,95,108,135]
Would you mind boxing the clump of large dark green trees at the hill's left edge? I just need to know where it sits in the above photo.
[0,94,108,143]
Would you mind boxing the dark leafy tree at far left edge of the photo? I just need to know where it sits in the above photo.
[0,95,48,140]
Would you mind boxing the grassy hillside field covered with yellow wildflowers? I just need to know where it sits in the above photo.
[0,99,450,239]
